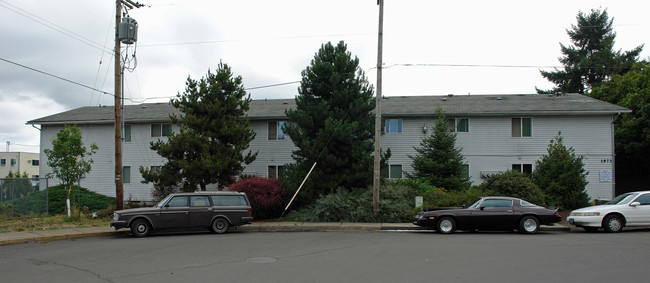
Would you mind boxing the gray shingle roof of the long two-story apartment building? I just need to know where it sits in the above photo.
[27,94,631,125]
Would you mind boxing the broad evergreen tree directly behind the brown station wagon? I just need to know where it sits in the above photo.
[140,63,257,191]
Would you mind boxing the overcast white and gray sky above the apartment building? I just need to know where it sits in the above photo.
[0,0,650,155]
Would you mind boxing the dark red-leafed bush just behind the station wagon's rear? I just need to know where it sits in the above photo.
[228,177,289,219]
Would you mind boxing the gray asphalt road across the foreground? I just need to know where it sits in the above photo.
[0,230,650,283]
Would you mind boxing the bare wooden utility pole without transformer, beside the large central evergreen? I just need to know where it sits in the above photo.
[372,0,384,214]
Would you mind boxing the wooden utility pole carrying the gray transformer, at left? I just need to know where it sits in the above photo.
[115,0,124,210]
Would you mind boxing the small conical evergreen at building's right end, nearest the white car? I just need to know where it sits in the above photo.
[532,133,589,209]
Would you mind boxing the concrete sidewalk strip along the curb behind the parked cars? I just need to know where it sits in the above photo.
[0,224,570,246]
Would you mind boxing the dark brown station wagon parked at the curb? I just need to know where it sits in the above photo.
[111,191,253,237]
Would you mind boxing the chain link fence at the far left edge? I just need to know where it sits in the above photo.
[0,178,50,217]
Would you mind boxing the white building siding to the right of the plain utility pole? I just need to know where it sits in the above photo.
[381,116,614,198]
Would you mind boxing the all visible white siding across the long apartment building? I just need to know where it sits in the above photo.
[40,115,613,201]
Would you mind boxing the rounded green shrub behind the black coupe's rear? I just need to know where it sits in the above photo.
[479,171,546,206]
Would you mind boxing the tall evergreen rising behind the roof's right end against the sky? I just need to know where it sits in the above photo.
[537,9,643,94]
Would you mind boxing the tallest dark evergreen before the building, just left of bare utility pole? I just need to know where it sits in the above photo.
[284,41,375,201]
